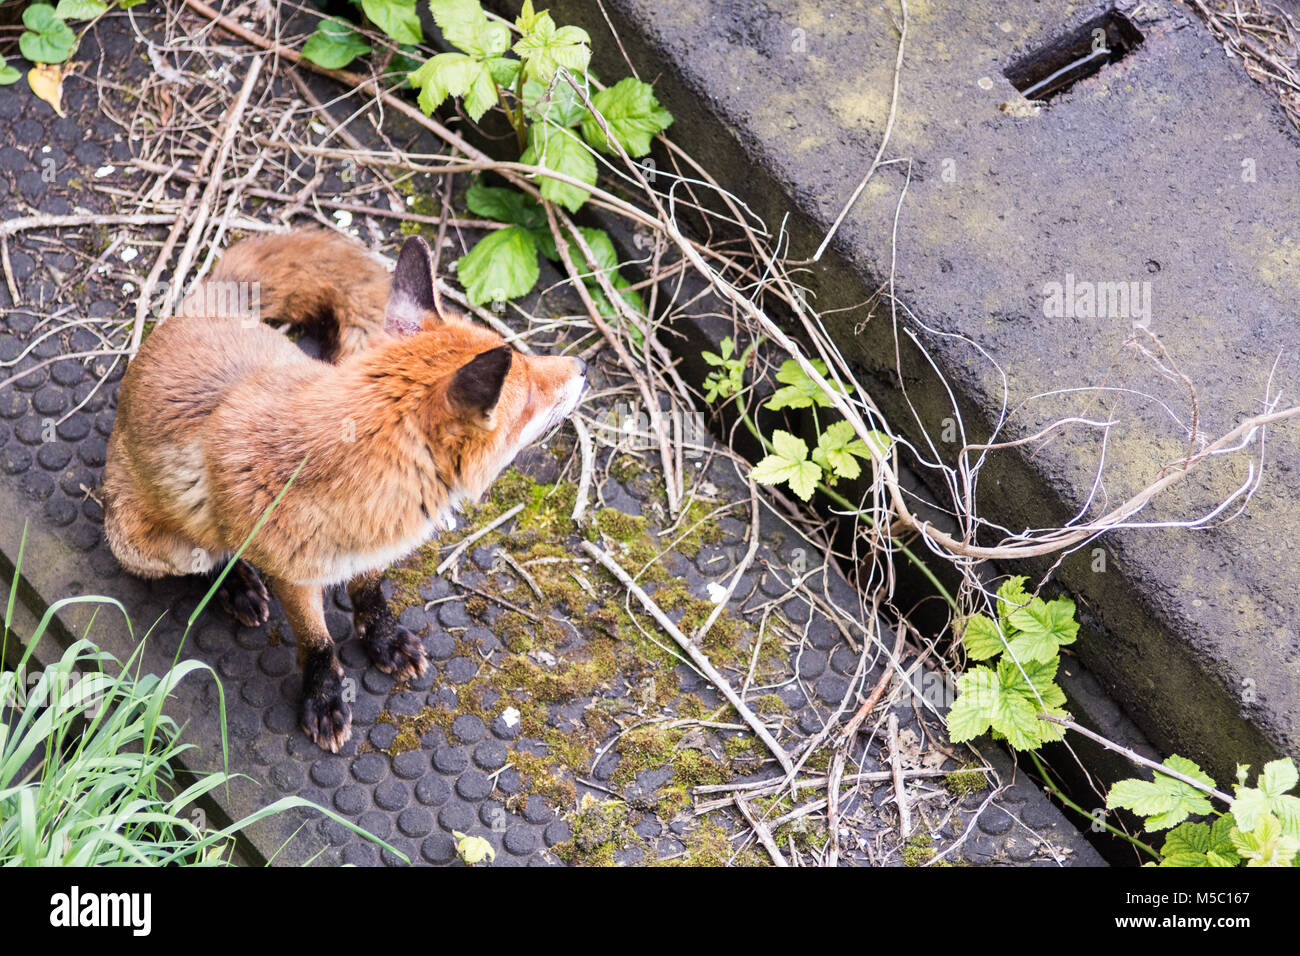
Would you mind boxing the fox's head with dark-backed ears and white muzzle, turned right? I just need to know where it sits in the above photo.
[385,237,586,502]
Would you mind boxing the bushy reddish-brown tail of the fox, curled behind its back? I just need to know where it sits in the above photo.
[181,229,393,362]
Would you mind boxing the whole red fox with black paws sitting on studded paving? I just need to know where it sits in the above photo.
[103,232,586,753]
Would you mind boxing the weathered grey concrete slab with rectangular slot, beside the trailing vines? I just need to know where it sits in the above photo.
[527,0,1300,779]
